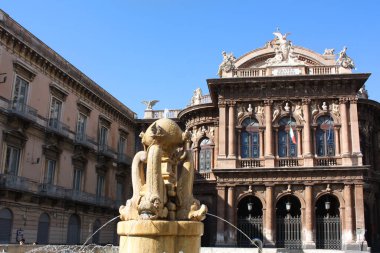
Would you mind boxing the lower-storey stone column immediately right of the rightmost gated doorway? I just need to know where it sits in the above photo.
[342,184,354,249]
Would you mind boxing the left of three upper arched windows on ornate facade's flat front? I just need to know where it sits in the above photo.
[240,118,260,158]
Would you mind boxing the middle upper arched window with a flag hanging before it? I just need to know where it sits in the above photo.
[278,117,298,157]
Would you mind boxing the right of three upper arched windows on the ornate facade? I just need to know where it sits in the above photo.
[315,115,335,156]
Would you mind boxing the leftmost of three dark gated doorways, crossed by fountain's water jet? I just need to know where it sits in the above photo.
[237,196,263,247]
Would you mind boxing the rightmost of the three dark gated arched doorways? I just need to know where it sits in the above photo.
[315,194,342,250]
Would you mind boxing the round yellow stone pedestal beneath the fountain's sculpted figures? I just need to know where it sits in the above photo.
[117,220,203,253]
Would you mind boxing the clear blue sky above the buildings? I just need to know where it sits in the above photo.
[0,0,380,117]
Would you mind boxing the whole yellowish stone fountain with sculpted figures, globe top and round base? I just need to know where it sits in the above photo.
[117,118,207,253]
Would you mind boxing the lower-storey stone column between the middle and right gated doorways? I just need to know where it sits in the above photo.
[303,185,315,249]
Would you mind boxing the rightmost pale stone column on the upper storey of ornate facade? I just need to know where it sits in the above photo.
[350,98,363,165]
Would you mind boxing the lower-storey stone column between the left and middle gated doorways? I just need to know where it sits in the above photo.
[264,185,276,247]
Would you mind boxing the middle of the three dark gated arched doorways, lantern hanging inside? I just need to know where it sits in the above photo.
[276,195,302,249]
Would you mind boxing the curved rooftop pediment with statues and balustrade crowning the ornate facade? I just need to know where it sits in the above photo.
[218,29,355,78]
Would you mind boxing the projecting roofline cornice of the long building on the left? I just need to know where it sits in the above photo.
[0,10,136,125]
